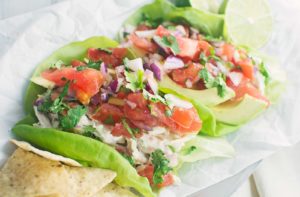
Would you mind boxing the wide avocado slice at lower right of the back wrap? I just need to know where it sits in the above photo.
[211,94,268,125]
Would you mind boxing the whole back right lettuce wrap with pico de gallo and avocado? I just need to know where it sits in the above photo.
[119,0,284,136]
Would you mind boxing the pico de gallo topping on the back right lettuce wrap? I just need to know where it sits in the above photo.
[123,21,269,103]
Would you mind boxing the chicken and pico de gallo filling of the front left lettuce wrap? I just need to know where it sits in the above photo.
[34,48,202,187]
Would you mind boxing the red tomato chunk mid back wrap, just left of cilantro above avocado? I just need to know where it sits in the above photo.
[172,62,203,86]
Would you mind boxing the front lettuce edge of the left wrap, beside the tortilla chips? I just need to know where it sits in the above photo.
[12,124,155,197]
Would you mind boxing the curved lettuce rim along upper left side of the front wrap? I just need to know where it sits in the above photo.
[24,36,119,116]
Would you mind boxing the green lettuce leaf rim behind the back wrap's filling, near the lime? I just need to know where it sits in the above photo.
[119,0,224,40]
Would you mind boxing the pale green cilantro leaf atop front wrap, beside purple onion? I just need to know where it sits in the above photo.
[124,70,144,92]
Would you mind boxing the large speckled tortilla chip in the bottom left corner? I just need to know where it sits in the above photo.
[0,148,116,197]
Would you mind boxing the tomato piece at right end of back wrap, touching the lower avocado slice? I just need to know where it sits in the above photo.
[226,76,269,103]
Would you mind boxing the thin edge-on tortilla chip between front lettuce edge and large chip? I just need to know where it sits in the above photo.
[10,139,81,166]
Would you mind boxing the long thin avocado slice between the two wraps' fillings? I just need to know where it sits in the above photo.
[158,75,235,107]
